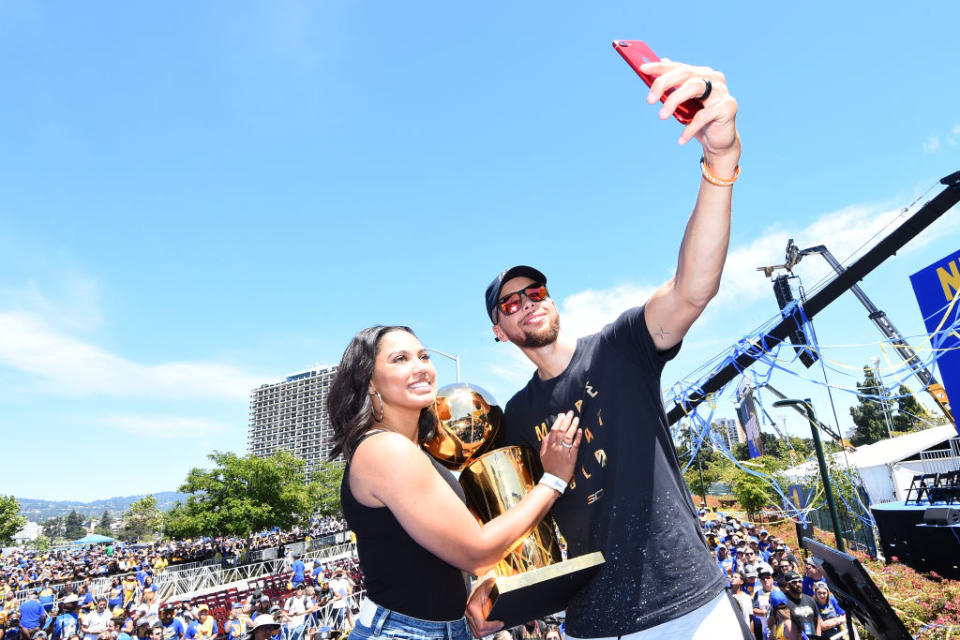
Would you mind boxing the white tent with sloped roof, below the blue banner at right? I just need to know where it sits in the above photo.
[784,424,960,504]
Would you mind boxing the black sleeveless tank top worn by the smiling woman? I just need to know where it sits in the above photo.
[340,431,467,620]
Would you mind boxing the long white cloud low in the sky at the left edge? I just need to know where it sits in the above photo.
[0,311,262,399]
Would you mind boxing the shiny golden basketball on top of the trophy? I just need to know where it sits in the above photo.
[424,382,503,471]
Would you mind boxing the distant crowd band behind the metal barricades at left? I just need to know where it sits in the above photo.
[0,516,346,602]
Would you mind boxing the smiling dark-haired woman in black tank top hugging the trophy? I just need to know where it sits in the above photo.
[327,326,582,640]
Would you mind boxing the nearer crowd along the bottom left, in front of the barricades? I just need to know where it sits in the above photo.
[0,557,363,640]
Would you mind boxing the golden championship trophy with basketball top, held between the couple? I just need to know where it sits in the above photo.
[426,383,603,628]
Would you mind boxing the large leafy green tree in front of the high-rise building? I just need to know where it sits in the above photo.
[165,450,322,538]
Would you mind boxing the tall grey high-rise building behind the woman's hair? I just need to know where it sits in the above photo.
[247,366,337,473]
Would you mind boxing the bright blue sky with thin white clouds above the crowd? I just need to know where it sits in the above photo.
[0,1,960,500]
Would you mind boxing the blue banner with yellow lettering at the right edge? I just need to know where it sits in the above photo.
[910,251,960,433]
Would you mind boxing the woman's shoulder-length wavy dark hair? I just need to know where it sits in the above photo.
[327,325,437,461]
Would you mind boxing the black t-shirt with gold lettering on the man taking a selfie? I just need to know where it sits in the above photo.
[503,307,726,638]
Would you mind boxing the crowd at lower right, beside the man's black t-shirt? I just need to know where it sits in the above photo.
[700,510,846,640]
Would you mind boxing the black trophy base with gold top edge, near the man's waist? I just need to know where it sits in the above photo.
[486,551,604,629]
